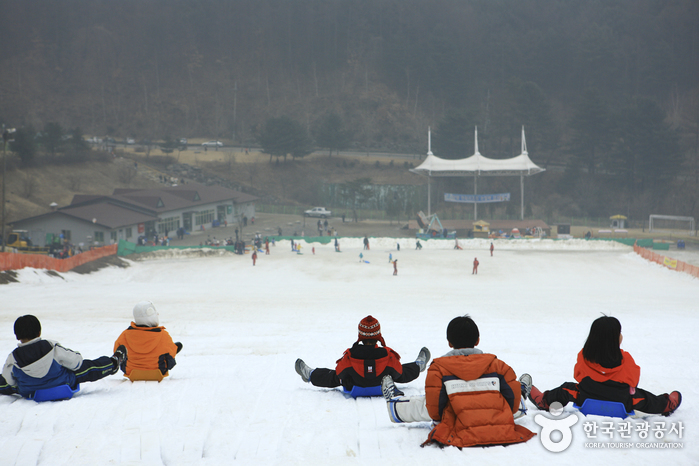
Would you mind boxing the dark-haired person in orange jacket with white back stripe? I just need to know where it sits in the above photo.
[381,315,534,448]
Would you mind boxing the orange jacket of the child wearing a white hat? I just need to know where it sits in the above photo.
[114,322,177,376]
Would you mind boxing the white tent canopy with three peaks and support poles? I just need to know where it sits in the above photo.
[410,127,545,220]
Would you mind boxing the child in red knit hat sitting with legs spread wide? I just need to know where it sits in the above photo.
[295,316,430,391]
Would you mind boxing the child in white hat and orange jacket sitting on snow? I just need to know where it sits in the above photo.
[114,301,182,377]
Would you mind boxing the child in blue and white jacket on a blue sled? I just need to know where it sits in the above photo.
[0,315,127,398]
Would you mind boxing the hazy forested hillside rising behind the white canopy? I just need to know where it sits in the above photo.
[0,0,699,220]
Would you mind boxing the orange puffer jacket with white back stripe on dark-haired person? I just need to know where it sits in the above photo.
[425,348,535,448]
